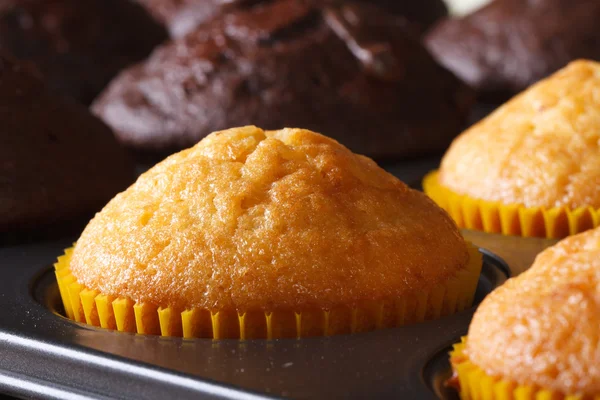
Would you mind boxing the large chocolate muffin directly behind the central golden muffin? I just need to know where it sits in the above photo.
[93,0,473,159]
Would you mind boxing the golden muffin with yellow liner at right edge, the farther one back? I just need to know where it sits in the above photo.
[425,60,600,237]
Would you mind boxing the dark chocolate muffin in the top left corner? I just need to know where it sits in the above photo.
[0,0,167,104]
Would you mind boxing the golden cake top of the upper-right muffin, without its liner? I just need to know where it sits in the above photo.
[439,61,600,208]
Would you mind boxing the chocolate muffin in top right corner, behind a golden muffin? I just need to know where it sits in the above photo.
[426,0,600,100]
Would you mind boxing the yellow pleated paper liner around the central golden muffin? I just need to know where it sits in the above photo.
[54,245,482,339]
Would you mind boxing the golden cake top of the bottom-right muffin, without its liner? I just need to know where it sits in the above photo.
[467,229,600,395]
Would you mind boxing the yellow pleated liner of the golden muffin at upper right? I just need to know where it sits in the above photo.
[423,171,600,239]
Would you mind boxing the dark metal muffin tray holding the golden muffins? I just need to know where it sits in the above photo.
[0,227,553,399]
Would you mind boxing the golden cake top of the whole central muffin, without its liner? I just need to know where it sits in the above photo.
[71,126,469,311]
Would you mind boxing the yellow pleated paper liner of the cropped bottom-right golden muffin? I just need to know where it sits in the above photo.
[450,337,600,400]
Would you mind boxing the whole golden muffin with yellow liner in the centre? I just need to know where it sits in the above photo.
[57,126,481,339]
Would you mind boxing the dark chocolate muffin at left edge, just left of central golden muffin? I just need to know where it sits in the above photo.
[0,51,134,236]
